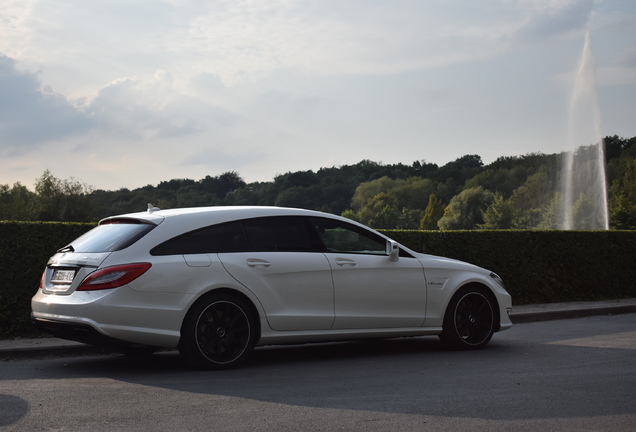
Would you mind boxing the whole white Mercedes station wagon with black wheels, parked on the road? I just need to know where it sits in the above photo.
[31,205,512,369]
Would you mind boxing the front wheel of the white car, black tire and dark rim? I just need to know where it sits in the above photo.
[439,286,497,350]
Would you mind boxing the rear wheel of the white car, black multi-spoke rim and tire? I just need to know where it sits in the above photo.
[179,294,258,369]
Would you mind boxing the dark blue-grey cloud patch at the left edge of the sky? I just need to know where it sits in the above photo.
[0,55,91,155]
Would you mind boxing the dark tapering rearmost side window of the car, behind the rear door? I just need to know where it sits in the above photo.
[150,222,248,255]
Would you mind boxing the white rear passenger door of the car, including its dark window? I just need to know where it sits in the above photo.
[218,216,334,331]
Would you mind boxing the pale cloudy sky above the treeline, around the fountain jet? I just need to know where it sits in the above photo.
[0,0,636,190]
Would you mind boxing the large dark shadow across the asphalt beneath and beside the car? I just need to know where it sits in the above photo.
[4,315,636,420]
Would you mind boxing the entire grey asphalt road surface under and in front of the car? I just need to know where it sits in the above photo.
[0,313,636,432]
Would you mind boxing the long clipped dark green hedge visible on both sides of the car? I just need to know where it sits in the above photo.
[0,222,636,338]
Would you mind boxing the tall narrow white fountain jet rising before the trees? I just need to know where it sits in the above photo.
[559,32,609,230]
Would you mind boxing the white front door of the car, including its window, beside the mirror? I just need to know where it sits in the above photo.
[311,218,426,330]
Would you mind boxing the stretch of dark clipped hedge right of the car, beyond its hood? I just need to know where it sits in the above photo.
[384,230,636,305]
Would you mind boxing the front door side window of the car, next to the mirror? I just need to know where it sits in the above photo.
[310,218,386,255]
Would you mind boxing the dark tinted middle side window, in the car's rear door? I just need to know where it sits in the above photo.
[242,216,315,252]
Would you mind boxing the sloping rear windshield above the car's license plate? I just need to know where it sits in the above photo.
[61,221,156,253]
